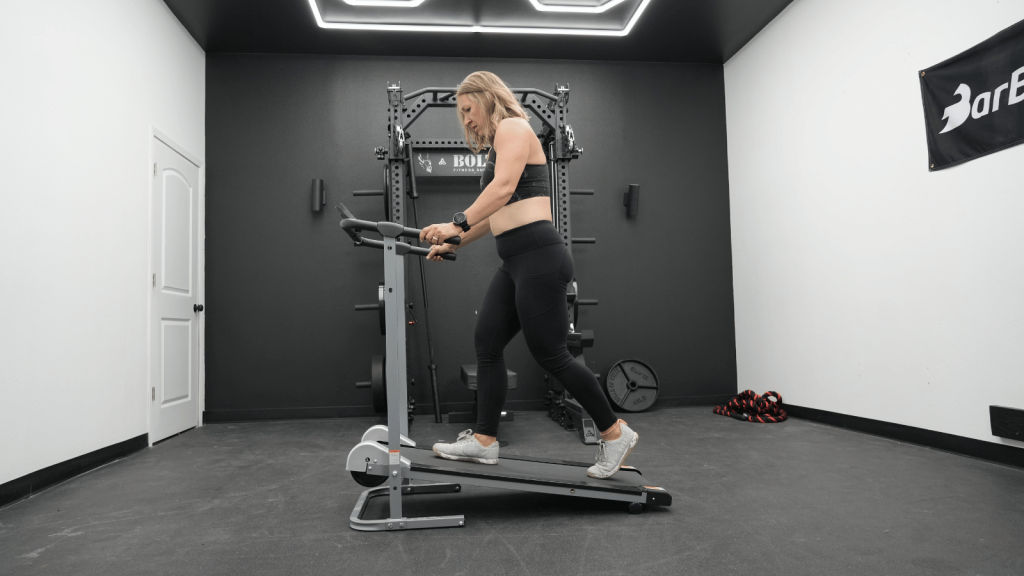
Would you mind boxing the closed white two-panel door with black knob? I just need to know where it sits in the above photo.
[150,137,200,442]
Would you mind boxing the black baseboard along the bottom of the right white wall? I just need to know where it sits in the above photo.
[784,404,1024,468]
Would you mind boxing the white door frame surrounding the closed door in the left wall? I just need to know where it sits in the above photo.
[144,125,206,447]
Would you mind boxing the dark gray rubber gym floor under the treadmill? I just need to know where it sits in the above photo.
[0,408,1024,576]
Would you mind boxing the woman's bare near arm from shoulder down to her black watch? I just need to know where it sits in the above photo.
[465,118,537,226]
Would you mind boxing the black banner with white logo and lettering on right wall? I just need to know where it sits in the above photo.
[921,20,1024,170]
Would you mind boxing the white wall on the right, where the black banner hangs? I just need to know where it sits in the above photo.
[725,0,1024,446]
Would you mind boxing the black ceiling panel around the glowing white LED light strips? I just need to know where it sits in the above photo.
[164,0,793,64]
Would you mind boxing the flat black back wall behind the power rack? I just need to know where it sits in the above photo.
[206,54,736,420]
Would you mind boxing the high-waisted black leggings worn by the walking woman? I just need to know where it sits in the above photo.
[474,220,617,436]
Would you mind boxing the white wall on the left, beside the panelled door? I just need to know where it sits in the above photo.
[0,0,206,483]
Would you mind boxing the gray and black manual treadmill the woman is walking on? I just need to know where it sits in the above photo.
[338,204,672,531]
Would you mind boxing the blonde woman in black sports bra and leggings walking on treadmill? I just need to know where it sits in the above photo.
[420,72,639,478]
